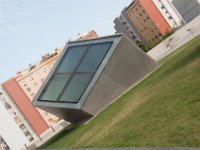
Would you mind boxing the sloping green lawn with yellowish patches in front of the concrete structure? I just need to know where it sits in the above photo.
[41,36,200,148]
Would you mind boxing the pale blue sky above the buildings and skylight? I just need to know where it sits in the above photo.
[0,0,132,83]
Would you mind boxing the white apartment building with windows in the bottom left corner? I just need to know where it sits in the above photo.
[0,85,37,150]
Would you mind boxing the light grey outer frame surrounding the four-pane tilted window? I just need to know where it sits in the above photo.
[32,34,124,109]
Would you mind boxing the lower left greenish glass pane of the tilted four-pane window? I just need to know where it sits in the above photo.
[40,74,70,101]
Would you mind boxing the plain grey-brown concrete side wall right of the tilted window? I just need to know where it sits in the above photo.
[81,37,157,115]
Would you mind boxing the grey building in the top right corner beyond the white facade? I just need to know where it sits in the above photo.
[172,0,200,23]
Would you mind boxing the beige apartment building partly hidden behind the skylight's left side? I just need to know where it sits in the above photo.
[16,48,62,126]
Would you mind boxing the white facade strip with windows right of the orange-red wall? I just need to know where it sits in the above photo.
[153,0,183,28]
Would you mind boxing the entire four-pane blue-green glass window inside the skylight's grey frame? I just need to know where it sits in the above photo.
[38,42,113,103]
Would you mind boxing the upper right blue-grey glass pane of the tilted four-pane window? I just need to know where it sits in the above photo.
[77,42,112,72]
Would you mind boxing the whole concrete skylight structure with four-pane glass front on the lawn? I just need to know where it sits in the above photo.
[33,34,157,123]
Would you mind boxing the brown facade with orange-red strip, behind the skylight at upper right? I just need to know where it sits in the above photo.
[127,0,172,43]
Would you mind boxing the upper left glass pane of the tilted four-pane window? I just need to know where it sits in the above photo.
[57,46,87,73]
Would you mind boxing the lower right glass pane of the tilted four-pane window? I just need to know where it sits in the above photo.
[60,74,93,102]
